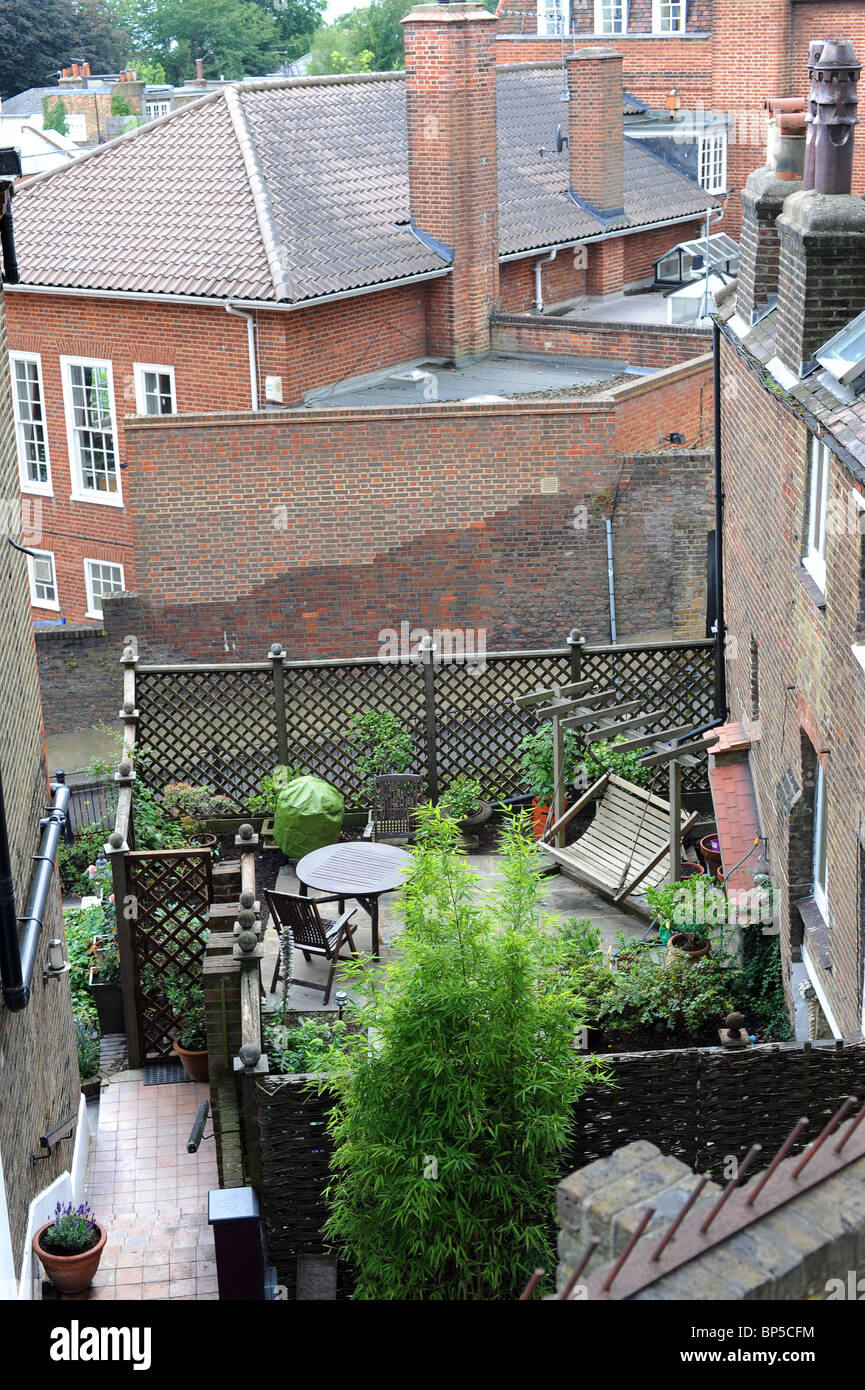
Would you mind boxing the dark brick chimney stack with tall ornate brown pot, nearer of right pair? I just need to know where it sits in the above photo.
[777,40,865,375]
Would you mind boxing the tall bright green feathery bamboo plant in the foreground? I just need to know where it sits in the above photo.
[325,808,602,1300]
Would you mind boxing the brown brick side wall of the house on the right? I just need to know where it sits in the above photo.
[722,330,865,1037]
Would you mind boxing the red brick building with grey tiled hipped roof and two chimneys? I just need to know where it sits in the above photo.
[8,6,713,621]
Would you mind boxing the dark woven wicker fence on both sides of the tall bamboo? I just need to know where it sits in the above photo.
[256,1043,865,1297]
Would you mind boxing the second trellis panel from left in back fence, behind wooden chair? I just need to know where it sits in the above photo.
[285,662,427,806]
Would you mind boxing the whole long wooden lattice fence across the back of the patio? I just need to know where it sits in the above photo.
[135,641,715,812]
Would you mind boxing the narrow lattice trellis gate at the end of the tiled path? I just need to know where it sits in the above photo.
[127,849,213,1056]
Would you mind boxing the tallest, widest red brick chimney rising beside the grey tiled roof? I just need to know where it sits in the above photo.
[402,4,499,359]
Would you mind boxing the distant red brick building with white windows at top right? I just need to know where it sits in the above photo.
[496,0,865,236]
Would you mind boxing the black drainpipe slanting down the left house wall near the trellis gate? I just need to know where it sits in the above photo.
[0,773,71,1013]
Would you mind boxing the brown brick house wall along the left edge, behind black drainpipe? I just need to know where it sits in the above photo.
[0,287,79,1261]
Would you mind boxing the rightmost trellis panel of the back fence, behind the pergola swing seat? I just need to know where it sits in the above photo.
[581,645,715,791]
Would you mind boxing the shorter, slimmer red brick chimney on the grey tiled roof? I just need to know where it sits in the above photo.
[567,47,624,220]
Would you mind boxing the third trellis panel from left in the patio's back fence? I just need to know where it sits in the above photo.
[435,652,570,798]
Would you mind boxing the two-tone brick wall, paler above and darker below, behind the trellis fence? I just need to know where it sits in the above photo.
[106,359,711,660]
